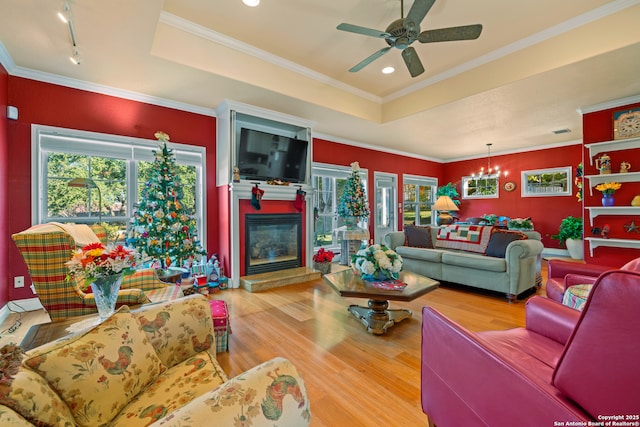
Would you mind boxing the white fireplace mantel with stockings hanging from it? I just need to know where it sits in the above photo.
[229,181,313,288]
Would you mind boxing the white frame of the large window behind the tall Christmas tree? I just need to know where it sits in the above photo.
[31,125,207,248]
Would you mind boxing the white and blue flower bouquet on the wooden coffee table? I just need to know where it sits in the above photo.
[351,245,402,281]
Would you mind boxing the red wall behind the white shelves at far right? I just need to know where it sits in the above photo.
[582,103,640,267]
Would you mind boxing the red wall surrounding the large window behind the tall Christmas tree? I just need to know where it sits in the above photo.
[5,76,218,300]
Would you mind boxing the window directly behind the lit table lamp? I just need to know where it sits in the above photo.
[402,175,438,225]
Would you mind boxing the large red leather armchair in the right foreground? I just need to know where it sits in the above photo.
[421,270,640,427]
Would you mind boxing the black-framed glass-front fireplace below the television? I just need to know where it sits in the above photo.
[244,213,302,275]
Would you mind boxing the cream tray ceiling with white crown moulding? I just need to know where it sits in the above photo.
[0,0,640,161]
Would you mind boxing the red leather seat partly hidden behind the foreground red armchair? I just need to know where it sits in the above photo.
[545,258,640,302]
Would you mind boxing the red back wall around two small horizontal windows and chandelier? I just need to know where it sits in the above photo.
[442,144,582,248]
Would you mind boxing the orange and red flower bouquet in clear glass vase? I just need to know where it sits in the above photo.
[66,243,139,320]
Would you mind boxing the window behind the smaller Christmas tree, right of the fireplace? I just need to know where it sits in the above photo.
[311,163,368,250]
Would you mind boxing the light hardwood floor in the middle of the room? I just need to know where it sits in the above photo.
[0,263,546,427]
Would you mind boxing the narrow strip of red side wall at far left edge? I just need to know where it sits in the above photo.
[0,65,9,307]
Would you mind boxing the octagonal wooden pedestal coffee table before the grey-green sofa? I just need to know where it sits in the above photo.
[324,269,440,335]
